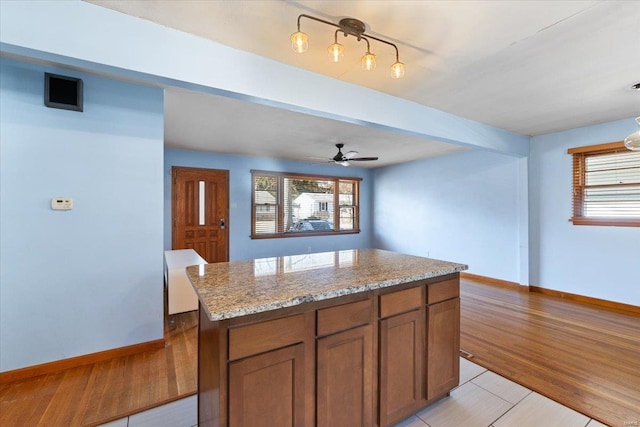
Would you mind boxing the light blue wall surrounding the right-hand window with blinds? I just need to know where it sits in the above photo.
[529,118,640,305]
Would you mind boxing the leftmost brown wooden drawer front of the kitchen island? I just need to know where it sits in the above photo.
[229,314,305,360]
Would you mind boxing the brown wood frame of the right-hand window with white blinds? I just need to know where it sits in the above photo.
[567,141,640,227]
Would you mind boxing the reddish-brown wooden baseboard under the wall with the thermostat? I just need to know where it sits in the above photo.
[0,338,165,384]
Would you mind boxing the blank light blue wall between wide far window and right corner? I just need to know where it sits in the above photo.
[373,150,528,284]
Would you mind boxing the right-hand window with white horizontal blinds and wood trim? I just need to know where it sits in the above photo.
[568,142,640,227]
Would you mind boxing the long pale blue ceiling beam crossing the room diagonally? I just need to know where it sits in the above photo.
[0,1,530,157]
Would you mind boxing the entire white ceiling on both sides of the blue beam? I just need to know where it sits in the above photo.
[90,0,640,167]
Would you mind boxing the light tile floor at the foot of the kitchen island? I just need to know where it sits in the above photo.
[103,358,604,427]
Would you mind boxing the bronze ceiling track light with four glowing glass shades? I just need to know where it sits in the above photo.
[290,13,405,79]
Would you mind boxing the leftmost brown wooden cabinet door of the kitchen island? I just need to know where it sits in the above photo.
[229,344,305,427]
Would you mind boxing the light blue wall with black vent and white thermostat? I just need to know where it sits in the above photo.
[0,58,164,371]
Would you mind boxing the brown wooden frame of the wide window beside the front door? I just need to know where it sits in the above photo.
[250,170,362,239]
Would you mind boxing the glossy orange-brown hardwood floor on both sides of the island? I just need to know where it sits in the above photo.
[0,280,640,427]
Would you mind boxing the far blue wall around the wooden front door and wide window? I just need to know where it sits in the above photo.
[164,149,372,261]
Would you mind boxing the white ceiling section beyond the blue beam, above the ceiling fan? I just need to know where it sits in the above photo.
[165,90,464,167]
